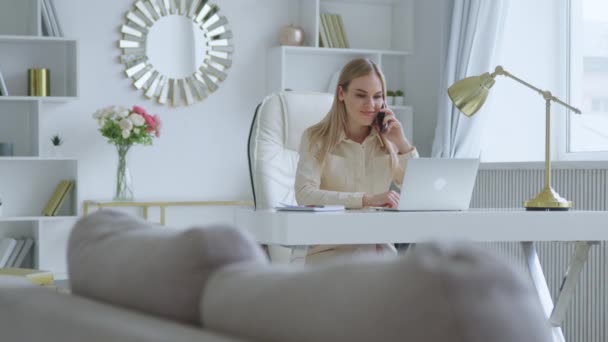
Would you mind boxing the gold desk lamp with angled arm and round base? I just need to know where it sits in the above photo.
[448,66,581,210]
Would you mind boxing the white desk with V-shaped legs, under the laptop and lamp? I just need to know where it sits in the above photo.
[236,209,608,342]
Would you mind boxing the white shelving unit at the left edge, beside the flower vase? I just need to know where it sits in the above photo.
[0,0,78,278]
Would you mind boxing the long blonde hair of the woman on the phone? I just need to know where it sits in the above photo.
[306,58,403,183]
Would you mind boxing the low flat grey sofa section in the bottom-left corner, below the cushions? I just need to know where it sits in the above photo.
[0,284,243,342]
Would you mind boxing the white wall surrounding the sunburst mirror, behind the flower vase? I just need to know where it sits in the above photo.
[41,0,304,227]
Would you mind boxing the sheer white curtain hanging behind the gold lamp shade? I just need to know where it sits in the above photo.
[432,0,507,158]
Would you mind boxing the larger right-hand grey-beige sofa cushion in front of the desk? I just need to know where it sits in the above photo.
[201,244,551,342]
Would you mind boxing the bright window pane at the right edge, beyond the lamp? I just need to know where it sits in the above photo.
[567,0,608,152]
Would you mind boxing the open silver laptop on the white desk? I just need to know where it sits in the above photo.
[376,158,479,211]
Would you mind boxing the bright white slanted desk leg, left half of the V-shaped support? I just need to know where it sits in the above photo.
[521,242,566,342]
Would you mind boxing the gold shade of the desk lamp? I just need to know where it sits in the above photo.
[448,73,494,116]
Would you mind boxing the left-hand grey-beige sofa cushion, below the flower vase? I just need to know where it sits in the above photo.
[68,210,267,325]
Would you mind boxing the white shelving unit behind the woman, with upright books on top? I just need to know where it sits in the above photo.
[267,0,414,139]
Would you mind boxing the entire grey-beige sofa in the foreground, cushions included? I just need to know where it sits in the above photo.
[0,210,550,342]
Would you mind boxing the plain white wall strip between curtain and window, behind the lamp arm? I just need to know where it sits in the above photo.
[476,0,567,162]
